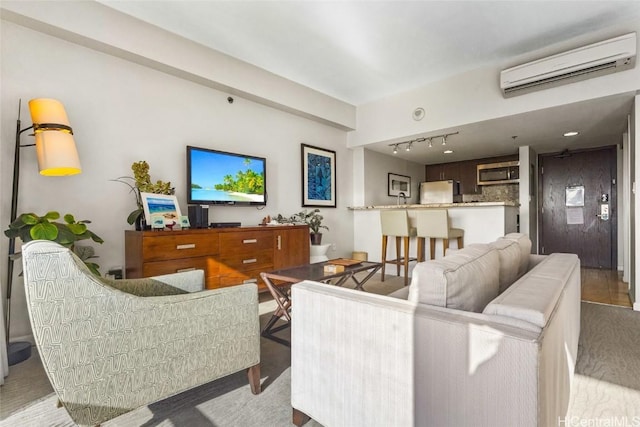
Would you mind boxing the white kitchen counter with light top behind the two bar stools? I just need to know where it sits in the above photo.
[349,202,520,278]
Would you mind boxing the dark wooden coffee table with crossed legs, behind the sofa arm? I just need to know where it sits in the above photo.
[260,259,382,346]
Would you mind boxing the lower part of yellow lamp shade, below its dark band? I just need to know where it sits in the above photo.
[35,130,82,176]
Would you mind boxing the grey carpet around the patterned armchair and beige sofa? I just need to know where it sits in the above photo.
[5,286,640,427]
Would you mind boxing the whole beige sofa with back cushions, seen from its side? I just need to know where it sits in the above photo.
[291,234,580,427]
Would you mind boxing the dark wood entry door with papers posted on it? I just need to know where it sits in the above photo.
[539,146,617,269]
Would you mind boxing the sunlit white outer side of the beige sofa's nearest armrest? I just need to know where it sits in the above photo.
[291,281,415,426]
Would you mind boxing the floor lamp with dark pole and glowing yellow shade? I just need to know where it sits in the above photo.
[5,98,81,365]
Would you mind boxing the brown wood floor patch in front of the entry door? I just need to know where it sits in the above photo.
[580,268,631,307]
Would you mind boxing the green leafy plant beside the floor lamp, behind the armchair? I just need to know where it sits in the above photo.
[4,211,104,276]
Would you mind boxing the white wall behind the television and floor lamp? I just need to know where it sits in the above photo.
[0,20,353,338]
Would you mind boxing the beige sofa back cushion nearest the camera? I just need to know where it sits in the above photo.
[409,244,500,312]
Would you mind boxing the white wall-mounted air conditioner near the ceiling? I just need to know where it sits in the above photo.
[500,33,636,98]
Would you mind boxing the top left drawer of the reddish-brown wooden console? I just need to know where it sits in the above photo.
[142,233,218,262]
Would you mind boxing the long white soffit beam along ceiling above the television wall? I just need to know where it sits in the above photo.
[0,0,355,130]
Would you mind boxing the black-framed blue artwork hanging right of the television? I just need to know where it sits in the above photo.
[301,144,336,208]
